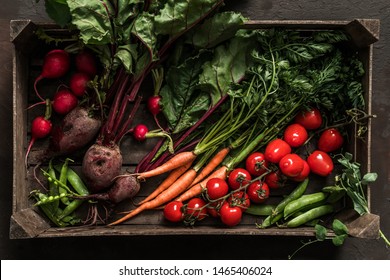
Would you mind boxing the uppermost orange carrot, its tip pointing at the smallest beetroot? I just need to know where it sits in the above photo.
[137,152,197,179]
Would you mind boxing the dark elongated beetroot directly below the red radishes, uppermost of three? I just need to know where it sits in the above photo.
[50,107,101,155]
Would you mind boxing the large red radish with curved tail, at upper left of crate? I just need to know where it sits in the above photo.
[34,49,70,101]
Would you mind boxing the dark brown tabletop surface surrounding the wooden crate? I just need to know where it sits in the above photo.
[0,0,390,260]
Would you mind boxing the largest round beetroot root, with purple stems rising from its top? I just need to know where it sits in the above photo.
[81,144,122,193]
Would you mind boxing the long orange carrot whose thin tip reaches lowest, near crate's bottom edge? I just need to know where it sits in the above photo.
[109,168,196,226]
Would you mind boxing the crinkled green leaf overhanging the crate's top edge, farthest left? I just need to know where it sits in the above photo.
[67,0,115,45]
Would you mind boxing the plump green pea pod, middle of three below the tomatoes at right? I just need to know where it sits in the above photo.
[284,192,328,219]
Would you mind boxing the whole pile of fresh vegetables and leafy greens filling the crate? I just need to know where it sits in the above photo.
[26,0,386,247]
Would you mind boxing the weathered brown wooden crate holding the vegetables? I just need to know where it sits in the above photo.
[10,19,379,239]
